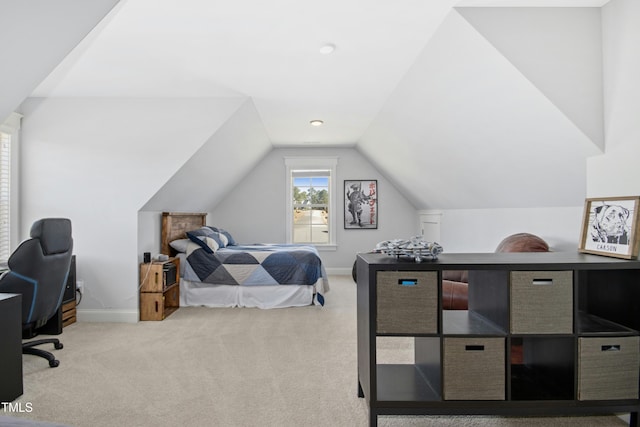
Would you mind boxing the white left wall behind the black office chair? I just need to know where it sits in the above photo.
[20,98,243,321]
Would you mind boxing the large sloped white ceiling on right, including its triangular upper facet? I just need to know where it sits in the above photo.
[358,8,603,209]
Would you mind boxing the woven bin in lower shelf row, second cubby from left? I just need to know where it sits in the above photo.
[443,337,506,400]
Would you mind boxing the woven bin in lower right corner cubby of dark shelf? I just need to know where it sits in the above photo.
[578,337,640,400]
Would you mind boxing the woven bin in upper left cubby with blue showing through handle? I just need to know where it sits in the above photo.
[376,271,438,334]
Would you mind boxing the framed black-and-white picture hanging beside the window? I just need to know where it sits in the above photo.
[344,179,378,230]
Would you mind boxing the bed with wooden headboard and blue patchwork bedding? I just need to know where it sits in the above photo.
[161,212,329,309]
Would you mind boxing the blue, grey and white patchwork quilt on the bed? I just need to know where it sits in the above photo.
[183,243,329,305]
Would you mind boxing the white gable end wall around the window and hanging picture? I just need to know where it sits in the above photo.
[207,148,418,269]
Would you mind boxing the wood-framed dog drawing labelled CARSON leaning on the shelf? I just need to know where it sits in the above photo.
[578,196,640,259]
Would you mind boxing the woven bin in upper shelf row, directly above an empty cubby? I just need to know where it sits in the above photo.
[510,271,573,334]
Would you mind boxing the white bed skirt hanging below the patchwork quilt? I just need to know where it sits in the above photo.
[180,279,318,308]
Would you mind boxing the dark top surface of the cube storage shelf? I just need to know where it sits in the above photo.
[358,251,640,270]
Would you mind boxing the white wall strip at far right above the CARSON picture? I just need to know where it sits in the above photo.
[587,0,640,197]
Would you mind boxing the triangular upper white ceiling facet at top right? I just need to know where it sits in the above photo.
[456,7,604,148]
